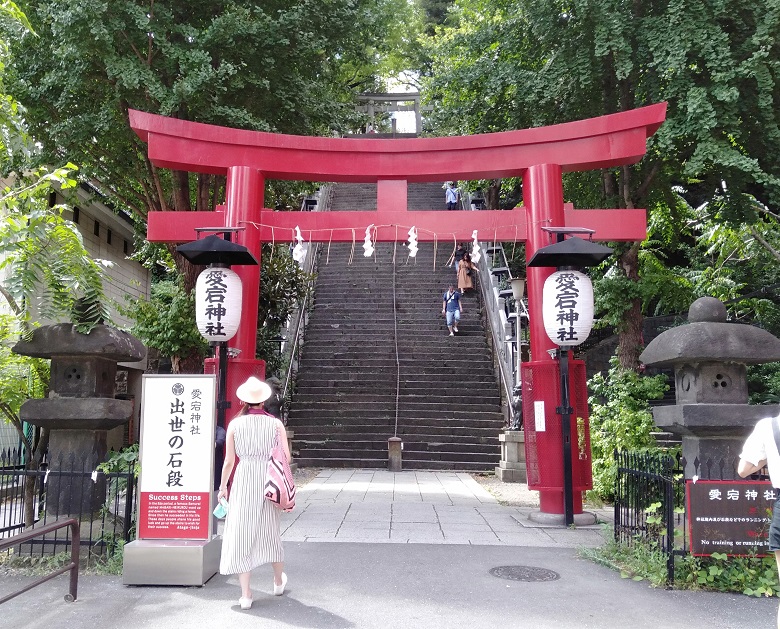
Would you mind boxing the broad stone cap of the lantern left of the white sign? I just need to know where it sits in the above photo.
[13,323,146,363]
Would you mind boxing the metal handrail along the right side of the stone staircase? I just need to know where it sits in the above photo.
[472,242,528,430]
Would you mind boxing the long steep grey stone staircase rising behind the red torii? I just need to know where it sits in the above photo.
[288,184,503,471]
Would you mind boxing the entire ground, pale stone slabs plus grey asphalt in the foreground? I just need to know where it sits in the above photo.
[0,470,777,629]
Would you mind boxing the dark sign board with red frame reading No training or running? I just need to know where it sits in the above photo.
[685,480,777,557]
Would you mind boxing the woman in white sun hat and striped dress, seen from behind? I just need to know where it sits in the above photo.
[217,377,290,609]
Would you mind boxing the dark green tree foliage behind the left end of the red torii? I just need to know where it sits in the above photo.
[12,0,412,216]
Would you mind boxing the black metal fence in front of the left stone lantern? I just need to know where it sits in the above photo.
[0,449,136,556]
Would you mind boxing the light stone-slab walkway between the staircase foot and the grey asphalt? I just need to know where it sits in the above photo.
[282,469,604,548]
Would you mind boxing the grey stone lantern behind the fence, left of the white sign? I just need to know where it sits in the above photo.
[13,323,146,515]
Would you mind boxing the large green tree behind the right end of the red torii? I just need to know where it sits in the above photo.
[427,0,780,368]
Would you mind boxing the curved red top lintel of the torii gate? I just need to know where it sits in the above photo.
[130,103,666,182]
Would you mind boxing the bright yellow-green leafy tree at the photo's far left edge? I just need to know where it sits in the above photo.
[0,1,112,526]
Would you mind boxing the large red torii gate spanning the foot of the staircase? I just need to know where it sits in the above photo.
[130,103,666,513]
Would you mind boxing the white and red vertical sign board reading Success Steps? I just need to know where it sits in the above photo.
[138,375,216,540]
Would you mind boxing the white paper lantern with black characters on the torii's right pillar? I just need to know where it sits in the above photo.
[542,271,593,347]
